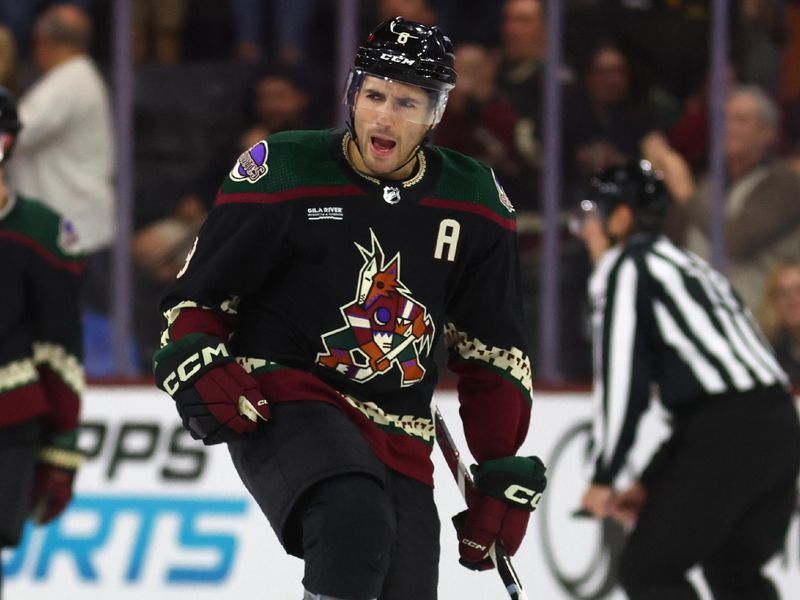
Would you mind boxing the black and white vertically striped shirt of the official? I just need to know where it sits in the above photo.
[589,234,787,484]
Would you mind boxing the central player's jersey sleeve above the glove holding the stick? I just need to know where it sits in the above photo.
[445,213,532,463]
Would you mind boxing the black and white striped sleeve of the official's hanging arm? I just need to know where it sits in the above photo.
[592,257,652,485]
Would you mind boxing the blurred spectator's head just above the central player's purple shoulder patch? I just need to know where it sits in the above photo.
[240,65,311,150]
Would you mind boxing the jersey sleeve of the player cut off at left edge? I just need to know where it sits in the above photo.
[27,215,86,433]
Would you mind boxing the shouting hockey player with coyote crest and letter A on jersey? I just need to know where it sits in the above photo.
[154,17,544,600]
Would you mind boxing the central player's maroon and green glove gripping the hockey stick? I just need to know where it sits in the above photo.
[453,456,547,571]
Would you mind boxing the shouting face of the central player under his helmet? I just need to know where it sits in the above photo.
[353,76,433,179]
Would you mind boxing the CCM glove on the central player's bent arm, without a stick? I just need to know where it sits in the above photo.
[153,333,270,445]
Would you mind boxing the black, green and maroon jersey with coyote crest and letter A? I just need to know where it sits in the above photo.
[162,131,531,483]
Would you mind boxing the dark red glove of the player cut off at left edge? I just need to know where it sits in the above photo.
[30,430,83,525]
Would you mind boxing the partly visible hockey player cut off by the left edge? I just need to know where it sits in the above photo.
[0,88,84,592]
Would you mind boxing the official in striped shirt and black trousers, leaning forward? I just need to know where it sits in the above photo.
[574,161,800,600]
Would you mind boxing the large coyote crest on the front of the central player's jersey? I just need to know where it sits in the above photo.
[317,229,435,387]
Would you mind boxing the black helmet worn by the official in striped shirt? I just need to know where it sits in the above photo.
[579,160,671,231]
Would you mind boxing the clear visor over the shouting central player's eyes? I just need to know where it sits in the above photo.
[342,69,447,127]
